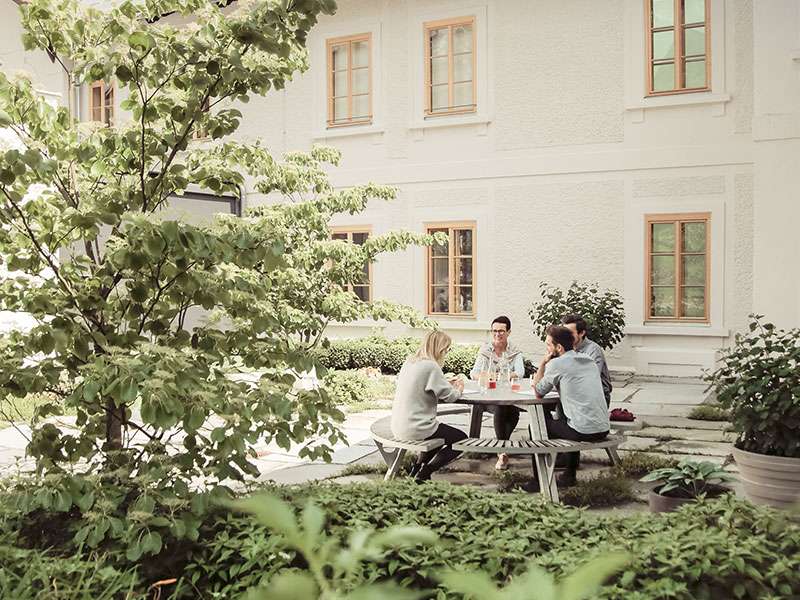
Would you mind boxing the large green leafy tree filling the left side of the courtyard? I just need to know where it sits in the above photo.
[0,0,433,551]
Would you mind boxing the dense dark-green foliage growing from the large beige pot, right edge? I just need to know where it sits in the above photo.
[705,315,800,458]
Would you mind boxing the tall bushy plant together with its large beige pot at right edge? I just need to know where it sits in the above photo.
[706,315,800,507]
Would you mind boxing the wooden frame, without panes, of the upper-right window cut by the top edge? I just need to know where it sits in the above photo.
[644,0,711,97]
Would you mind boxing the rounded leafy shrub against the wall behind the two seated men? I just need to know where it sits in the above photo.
[528,281,625,349]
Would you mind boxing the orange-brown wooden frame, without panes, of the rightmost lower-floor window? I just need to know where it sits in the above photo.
[644,212,711,324]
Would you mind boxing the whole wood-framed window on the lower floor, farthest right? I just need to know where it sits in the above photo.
[645,213,711,322]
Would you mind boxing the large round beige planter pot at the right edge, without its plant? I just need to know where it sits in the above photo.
[733,446,800,508]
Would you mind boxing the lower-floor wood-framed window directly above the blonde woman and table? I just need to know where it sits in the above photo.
[426,222,476,316]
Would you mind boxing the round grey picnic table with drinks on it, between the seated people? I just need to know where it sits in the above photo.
[456,380,558,502]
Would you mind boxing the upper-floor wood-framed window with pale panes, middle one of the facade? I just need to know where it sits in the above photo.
[423,17,477,116]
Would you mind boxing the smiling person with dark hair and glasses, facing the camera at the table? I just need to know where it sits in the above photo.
[469,316,525,470]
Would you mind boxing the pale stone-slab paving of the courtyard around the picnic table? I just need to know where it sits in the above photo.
[0,380,735,484]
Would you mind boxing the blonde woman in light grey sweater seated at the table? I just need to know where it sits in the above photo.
[392,331,467,482]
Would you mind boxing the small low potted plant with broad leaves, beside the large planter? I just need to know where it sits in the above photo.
[639,460,734,512]
